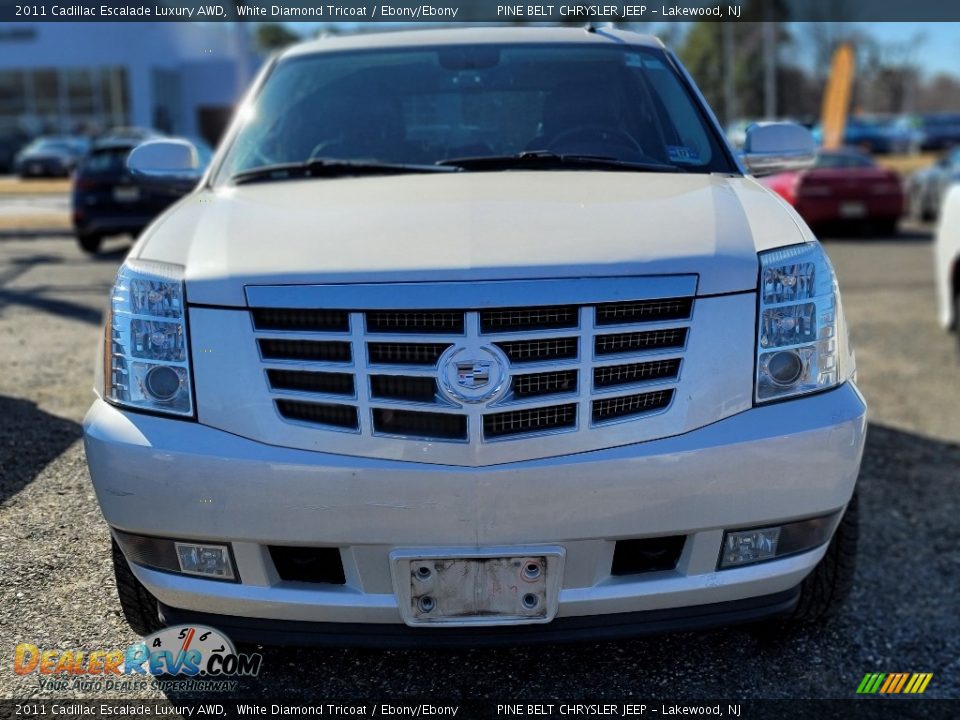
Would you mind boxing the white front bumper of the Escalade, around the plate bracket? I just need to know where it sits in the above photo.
[84,383,866,632]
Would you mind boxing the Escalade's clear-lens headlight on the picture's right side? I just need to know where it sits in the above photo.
[756,243,853,402]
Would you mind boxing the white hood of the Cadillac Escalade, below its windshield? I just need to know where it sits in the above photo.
[133,171,811,306]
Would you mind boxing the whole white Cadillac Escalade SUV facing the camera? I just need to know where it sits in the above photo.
[84,28,866,644]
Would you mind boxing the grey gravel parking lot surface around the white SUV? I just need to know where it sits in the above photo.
[0,207,960,700]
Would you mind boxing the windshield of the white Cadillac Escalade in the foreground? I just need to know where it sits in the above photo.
[217,44,737,182]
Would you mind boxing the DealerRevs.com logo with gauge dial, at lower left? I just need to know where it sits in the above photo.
[13,625,263,691]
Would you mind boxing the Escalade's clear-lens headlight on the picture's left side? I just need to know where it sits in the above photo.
[104,260,193,416]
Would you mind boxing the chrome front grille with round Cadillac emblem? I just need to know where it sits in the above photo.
[250,297,694,443]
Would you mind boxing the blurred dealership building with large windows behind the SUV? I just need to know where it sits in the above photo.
[0,22,261,142]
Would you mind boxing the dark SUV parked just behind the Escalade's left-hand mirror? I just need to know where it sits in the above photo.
[71,136,211,253]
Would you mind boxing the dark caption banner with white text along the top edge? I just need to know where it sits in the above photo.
[0,0,960,24]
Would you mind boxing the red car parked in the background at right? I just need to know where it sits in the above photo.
[761,150,904,235]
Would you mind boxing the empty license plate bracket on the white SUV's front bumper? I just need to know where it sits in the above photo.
[390,546,564,626]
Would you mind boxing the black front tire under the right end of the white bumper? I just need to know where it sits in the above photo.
[791,492,860,622]
